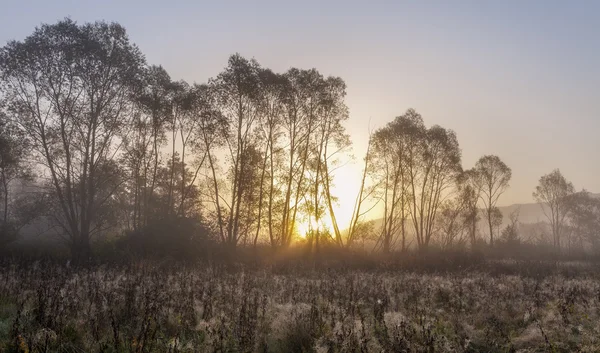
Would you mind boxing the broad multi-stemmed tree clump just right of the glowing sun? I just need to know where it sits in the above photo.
[373,109,462,252]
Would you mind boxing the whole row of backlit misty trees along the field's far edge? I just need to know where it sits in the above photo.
[0,19,600,261]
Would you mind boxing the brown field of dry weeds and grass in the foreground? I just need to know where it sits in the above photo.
[0,261,600,352]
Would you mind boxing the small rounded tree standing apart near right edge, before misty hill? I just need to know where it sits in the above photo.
[533,169,575,251]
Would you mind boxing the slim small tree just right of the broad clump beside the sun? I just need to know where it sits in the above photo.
[474,155,512,246]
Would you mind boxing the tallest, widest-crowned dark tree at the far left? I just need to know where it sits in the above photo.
[0,19,144,262]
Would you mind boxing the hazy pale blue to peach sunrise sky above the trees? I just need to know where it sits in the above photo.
[0,0,600,209]
